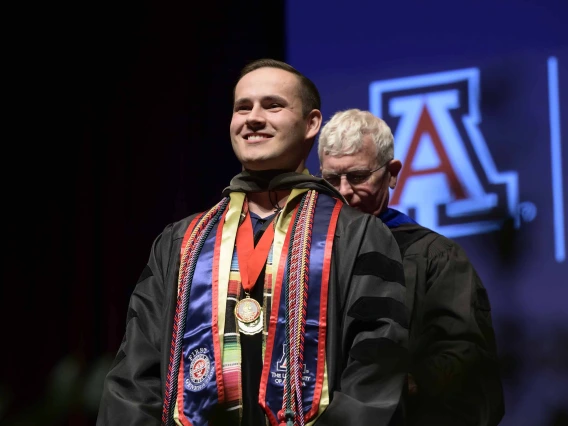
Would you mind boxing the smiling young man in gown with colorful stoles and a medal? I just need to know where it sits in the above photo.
[98,60,408,426]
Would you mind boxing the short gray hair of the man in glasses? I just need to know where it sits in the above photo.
[318,108,394,163]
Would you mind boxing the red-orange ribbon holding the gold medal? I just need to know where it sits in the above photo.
[237,200,274,296]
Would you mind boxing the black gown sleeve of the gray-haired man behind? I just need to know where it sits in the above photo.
[411,237,504,425]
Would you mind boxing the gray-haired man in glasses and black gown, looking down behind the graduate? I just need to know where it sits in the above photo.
[318,109,504,426]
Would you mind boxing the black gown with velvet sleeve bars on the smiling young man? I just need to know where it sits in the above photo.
[97,174,408,426]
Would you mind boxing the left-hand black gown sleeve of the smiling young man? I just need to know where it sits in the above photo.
[97,226,180,426]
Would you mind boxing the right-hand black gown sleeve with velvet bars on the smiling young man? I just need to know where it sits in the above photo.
[315,211,408,426]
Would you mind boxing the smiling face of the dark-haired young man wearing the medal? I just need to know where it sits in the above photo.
[230,68,321,172]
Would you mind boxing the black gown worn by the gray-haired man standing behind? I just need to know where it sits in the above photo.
[391,224,504,426]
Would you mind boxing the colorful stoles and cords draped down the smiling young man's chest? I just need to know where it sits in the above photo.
[163,189,341,426]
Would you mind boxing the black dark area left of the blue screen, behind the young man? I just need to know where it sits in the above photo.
[0,0,285,425]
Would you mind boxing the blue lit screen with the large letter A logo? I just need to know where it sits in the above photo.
[287,0,568,426]
